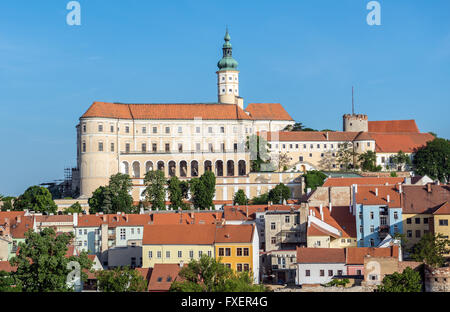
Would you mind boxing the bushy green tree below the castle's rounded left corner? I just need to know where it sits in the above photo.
[88,173,135,214]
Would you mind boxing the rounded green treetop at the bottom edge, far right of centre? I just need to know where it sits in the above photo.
[377,268,422,292]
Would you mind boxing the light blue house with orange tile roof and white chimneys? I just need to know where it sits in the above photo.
[352,185,403,247]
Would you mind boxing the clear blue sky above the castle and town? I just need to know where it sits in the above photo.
[0,0,450,195]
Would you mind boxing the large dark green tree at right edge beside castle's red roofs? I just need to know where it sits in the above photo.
[413,138,450,183]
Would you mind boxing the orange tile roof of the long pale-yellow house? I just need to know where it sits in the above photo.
[142,224,216,245]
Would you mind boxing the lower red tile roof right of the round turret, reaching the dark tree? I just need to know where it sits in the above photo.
[370,133,434,153]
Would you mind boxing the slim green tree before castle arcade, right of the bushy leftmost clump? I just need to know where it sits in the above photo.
[143,170,167,210]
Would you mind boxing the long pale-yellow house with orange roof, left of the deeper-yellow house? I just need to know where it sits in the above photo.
[142,224,216,268]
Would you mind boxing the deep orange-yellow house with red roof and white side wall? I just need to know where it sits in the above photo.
[214,224,259,283]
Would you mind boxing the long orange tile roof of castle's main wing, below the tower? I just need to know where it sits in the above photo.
[81,102,251,120]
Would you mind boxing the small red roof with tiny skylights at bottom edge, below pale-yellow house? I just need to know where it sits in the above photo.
[148,263,181,292]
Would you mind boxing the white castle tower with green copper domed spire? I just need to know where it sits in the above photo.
[216,29,243,106]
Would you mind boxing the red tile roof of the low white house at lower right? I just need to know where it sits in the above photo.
[297,247,345,263]
